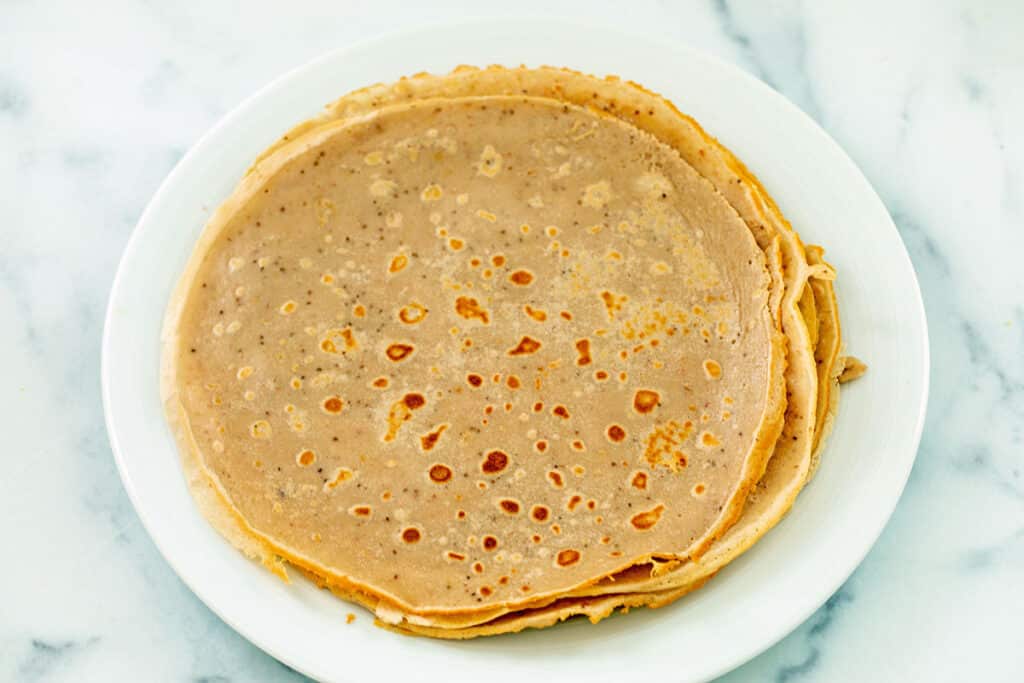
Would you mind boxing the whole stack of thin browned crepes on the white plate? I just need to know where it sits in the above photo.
[162,68,863,638]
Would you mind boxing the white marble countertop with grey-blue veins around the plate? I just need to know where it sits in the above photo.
[0,0,1024,683]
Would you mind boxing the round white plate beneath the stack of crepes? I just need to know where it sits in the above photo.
[102,22,928,683]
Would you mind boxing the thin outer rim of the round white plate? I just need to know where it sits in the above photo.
[100,15,931,680]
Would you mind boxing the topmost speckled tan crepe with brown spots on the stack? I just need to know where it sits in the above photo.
[165,89,781,613]
